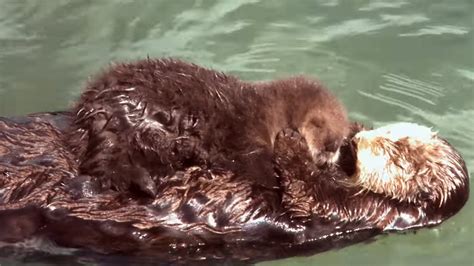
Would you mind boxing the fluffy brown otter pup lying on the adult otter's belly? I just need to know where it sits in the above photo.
[67,59,349,195]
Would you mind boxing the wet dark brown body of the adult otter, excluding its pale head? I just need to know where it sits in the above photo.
[0,114,469,265]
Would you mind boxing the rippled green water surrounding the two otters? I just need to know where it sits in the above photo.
[0,0,474,266]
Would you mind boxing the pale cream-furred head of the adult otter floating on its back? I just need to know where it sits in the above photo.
[353,123,468,206]
